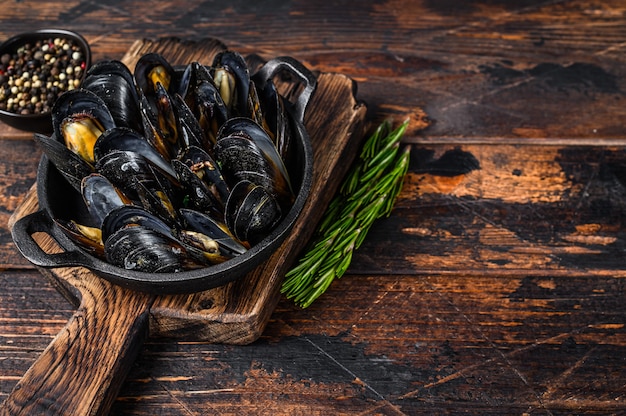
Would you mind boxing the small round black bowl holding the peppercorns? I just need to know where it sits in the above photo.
[0,29,91,134]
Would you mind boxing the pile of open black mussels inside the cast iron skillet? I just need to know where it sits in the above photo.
[35,50,295,273]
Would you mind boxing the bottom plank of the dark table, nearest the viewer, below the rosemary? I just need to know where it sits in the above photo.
[0,273,626,414]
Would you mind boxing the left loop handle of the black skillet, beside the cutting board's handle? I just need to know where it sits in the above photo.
[11,210,92,268]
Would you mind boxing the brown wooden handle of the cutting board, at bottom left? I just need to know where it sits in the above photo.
[0,278,154,416]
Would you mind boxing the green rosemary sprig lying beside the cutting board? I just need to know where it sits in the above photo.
[281,120,410,308]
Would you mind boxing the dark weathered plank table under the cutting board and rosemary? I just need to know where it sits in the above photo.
[0,0,626,415]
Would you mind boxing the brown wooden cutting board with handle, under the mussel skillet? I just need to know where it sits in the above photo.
[0,38,366,416]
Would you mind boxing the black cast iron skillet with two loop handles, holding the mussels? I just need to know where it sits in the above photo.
[12,57,316,294]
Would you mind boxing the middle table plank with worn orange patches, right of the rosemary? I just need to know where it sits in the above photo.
[351,144,626,277]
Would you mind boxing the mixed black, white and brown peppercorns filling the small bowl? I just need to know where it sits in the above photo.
[0,38,86,114]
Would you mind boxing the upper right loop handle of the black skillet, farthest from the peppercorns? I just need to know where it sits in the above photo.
[258,56,317,124]
